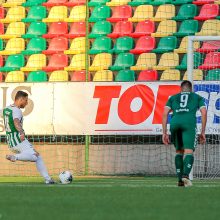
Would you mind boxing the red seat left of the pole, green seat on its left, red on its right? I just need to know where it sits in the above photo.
[42,22,68,38]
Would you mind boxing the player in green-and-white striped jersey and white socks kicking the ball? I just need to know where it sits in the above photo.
[3,91,54,184]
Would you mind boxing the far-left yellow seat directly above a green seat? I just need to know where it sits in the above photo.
[0,38,25,55]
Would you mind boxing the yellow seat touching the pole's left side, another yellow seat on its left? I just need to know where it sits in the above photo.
[64,5,86,22]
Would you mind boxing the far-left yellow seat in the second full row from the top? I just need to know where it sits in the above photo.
[0,22,25,39]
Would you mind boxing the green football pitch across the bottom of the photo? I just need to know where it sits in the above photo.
[0,177,220,220]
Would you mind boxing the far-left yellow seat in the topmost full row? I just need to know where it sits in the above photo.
[0,6,25,23]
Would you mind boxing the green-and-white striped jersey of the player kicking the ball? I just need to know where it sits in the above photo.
[3,105,23,147]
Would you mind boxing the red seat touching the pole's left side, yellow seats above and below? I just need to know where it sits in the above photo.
[64,22,86,38]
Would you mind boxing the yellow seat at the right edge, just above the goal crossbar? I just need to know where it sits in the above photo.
[196,19,220,36]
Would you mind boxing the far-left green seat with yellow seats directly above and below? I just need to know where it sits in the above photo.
[0,54,25,72]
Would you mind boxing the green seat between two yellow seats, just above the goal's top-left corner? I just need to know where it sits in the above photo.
[174,20,199,37]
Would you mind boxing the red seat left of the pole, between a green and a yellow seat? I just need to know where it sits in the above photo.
[42,37,68,55]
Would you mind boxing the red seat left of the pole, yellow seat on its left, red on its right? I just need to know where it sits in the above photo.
[42,54,68,72]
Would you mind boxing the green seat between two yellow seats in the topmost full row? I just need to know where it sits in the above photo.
[21,5,47,22]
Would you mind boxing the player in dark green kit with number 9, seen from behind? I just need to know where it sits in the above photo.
[162,80,207,186]
